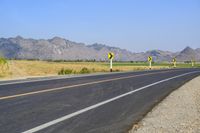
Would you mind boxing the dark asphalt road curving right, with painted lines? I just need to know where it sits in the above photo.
[0,69,200,133]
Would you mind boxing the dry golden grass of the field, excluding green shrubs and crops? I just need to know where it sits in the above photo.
[0,60,170,79]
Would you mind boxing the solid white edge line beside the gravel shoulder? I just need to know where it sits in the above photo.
[22,71,200,133]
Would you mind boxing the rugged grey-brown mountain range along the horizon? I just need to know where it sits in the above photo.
[0,36,200,61]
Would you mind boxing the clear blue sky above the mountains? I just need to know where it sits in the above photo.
[0,0,200,52]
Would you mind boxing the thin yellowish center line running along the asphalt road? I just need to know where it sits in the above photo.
[0,70,181,100]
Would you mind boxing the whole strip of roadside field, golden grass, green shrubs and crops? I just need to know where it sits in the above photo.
[0,58,200,79]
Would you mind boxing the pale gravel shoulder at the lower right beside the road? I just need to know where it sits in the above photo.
[129,76,200,133]
